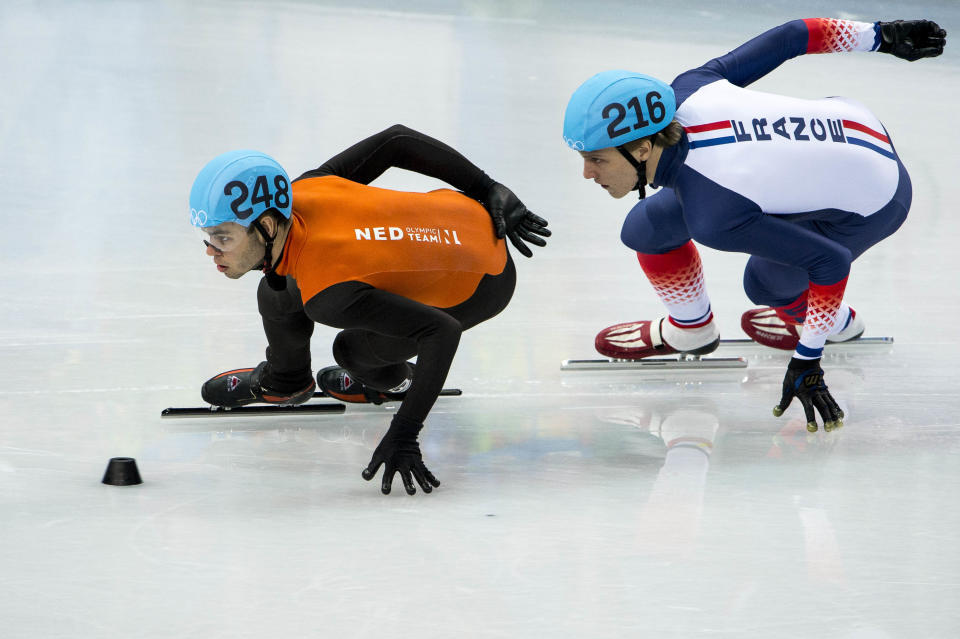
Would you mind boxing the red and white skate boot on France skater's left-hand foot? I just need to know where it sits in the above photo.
[594,317,720,359]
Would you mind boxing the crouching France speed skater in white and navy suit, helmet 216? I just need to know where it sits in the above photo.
[564,18,947,432]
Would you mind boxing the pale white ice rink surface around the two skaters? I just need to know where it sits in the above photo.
[0,0,960,639]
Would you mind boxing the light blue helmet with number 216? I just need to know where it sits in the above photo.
[563,71,677,151]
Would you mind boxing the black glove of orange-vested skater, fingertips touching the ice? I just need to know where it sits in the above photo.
[362,415,440,495]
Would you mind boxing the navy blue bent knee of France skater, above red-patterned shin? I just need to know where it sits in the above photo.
[620,188,690,255]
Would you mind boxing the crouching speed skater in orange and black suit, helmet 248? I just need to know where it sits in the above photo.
[190,125,550,495]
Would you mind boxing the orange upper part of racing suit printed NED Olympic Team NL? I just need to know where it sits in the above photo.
[276,175,507,308]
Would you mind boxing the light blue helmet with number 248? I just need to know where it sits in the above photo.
[190,150,291,228]
